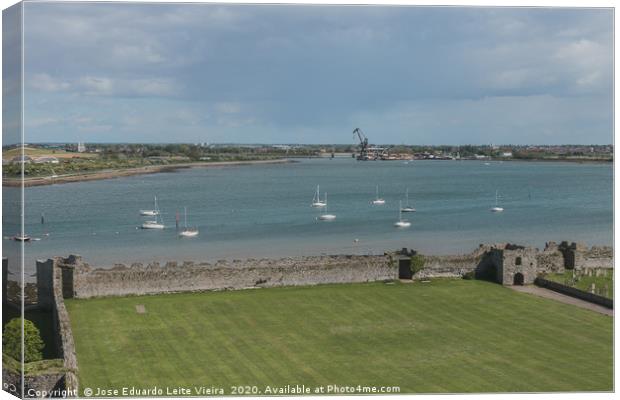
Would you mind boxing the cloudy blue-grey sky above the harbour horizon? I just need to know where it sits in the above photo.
[5,3,613,145]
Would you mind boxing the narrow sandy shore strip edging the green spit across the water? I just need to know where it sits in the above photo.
[2,158,296,187]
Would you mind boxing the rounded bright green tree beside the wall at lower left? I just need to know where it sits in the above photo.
[2,318,44,363]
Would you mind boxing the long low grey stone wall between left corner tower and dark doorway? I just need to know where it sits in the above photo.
[73,256,398,298]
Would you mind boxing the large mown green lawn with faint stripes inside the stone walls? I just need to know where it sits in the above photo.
[67,280,613,394]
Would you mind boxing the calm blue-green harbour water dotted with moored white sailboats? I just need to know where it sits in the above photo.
[4,159,613,276]
